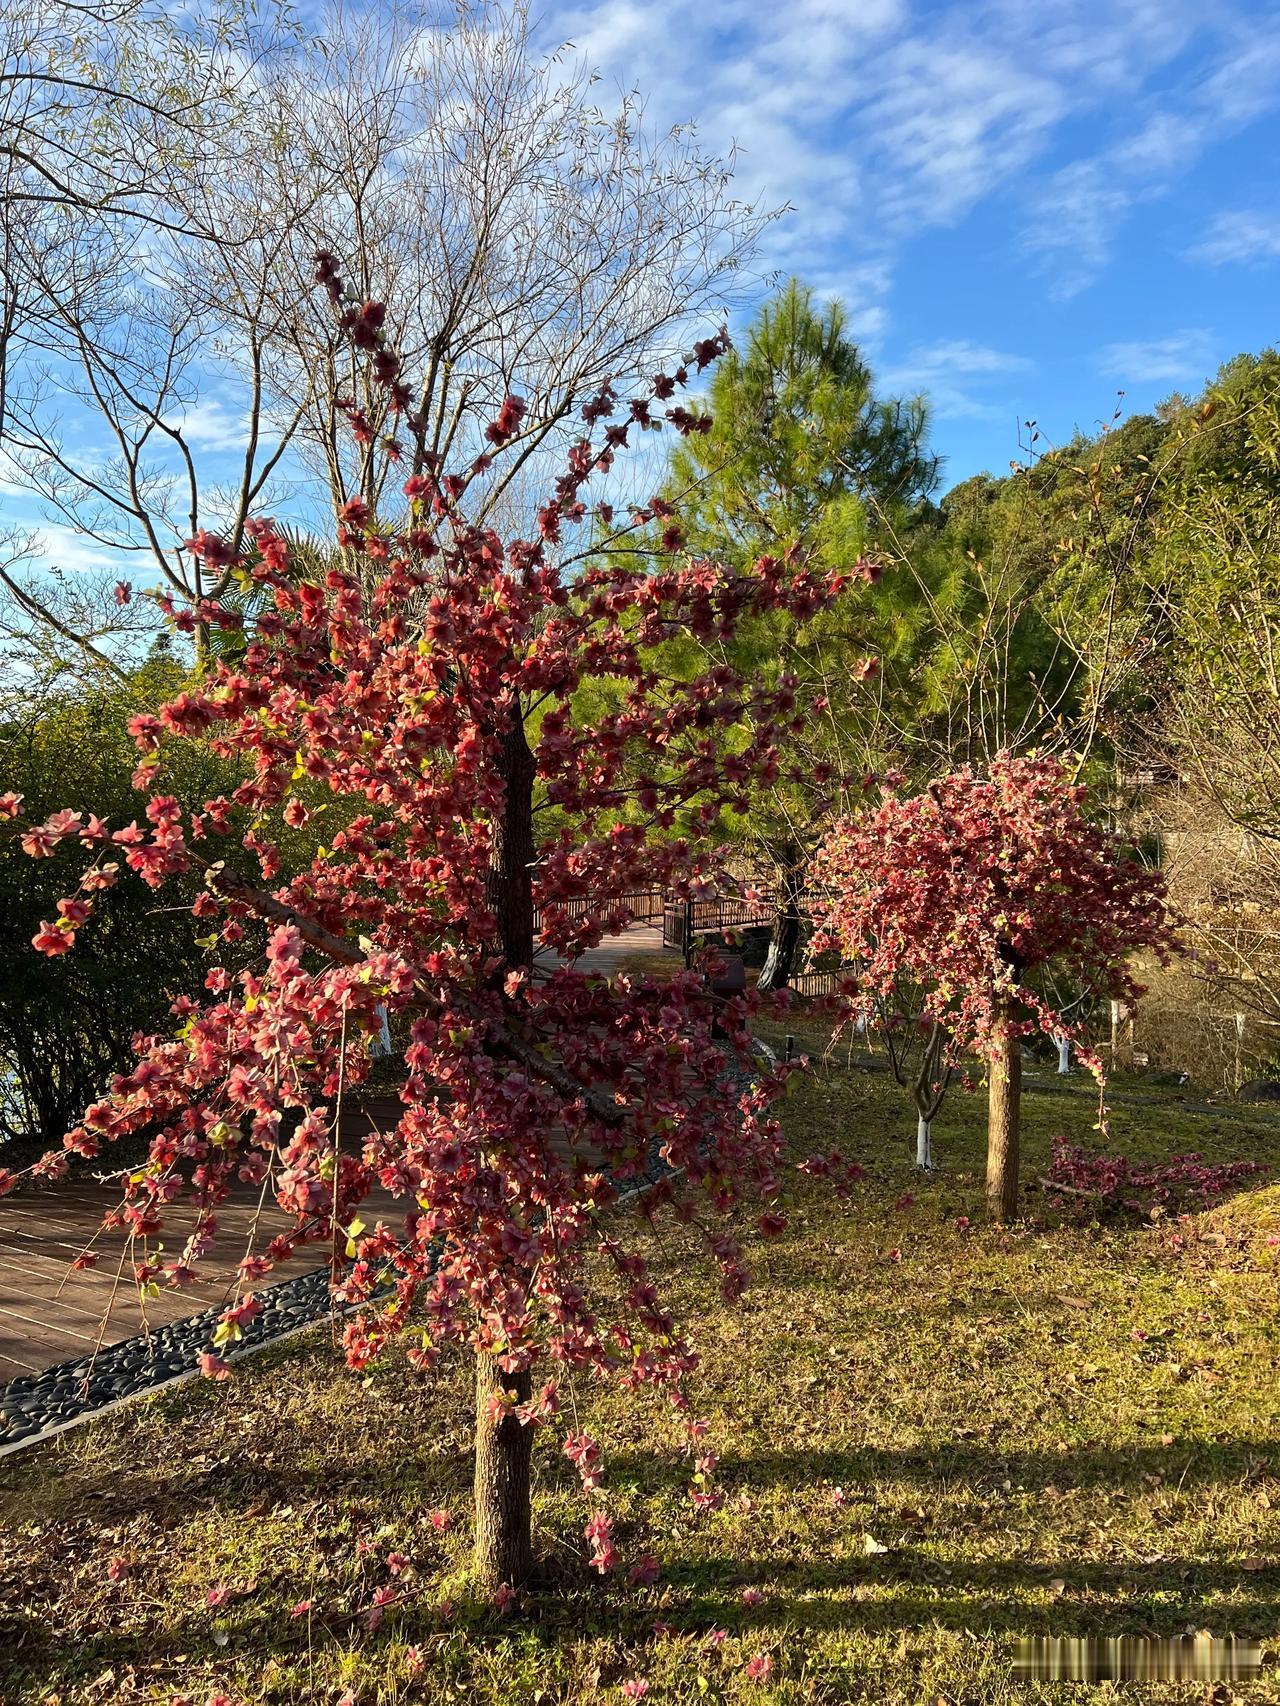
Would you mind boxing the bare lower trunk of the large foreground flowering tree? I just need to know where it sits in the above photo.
[474,1351,532,1590]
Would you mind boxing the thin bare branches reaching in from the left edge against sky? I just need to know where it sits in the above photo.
[0,0,278,670]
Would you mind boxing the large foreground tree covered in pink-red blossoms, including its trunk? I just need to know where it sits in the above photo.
[0,256,880,1590]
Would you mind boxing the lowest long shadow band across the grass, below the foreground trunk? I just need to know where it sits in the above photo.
[0,1547,1280,1697]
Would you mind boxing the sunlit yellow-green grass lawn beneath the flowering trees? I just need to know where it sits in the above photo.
[0,1044,1280,1706]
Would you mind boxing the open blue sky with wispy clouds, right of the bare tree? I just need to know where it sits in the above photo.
[546,0,1280,485]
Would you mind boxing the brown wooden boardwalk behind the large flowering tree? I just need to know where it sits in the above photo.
[0,923,678,1382]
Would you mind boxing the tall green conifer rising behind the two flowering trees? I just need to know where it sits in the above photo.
[607,280,939,988]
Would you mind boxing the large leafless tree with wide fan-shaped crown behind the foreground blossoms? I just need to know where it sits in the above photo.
[3,0,771,675]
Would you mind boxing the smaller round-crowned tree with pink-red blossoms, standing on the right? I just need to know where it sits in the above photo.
[812,754,1179,1220]
